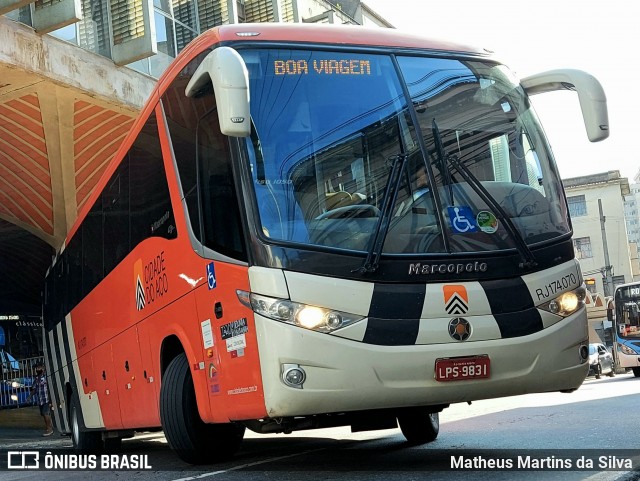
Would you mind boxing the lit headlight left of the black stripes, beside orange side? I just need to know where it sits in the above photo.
[237,291,364,333]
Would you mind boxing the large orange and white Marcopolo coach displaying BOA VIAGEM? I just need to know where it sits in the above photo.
[44,24,608,463]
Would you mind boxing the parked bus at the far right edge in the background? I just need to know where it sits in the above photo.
[607,282,640,377]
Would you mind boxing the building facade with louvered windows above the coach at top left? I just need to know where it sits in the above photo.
[0,0,392,78]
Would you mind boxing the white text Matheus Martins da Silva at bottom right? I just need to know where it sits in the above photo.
[451,455,633,470]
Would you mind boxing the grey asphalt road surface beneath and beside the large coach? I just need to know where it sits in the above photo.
[0,374,640,481]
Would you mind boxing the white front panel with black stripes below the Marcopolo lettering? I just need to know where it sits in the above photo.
[286,261,582,346]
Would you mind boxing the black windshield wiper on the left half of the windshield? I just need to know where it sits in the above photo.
[353,153,409,274]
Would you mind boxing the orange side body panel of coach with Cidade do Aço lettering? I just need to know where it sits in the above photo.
[71,93,266,430]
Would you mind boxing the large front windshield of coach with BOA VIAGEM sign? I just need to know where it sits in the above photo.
[240,49,569,254]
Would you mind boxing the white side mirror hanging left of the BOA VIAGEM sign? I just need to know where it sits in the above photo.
[185,47,251,137]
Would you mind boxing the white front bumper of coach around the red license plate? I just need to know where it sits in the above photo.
[256,308,589,417]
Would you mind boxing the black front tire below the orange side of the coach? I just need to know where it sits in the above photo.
[160,353,244,464]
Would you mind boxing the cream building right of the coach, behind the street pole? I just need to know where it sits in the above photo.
[562,170,637,296]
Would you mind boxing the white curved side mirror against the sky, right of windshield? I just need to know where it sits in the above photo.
[520,69,609,142]
